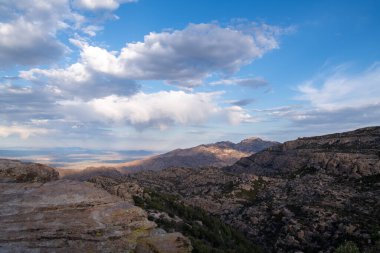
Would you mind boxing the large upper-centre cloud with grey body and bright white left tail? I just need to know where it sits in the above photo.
[21,24,284,88]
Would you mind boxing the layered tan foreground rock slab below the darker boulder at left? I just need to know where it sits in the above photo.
[0,180,155,252]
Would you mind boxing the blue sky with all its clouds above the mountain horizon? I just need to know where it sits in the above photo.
[0,0,380,151]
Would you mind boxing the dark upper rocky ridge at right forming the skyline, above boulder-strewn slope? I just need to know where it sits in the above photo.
[225,127,380,178]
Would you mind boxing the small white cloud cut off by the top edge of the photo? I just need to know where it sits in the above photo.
[73,0,137,11]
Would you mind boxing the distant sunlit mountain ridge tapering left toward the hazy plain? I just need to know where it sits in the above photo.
[59,137,279,181]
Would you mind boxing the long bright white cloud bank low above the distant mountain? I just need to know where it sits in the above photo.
[60,91,249,129]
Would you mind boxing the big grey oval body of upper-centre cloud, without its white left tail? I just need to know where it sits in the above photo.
[115,24,278,86]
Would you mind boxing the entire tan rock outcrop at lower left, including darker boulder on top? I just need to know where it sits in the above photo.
[0,160,191,253]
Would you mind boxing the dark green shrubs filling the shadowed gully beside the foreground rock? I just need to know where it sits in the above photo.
[135,191,259,253]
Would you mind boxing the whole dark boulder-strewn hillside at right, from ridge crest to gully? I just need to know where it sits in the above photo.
[111,127,380,252]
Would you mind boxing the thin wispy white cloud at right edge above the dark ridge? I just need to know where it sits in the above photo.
[258,64,380,130]
